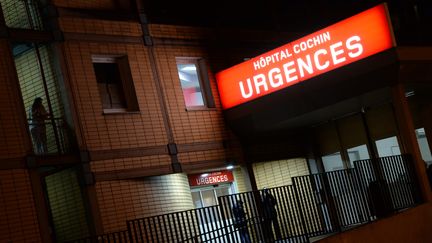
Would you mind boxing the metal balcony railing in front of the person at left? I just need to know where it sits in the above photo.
[28,118,75,155]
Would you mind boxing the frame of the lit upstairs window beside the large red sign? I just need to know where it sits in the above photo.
[176,57,216,111]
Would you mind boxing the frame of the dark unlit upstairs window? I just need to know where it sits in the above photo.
[91,54,140,114]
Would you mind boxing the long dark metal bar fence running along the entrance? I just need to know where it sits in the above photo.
[70,155,420,243]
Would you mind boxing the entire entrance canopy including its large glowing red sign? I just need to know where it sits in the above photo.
[216,4,399,135]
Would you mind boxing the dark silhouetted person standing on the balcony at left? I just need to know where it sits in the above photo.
[29,97,50,154]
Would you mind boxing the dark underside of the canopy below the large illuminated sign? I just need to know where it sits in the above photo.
[224,50,399,136]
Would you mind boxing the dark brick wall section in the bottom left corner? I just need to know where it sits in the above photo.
[0,169,41,242]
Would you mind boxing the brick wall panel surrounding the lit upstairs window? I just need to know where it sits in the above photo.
[156,44,226,143]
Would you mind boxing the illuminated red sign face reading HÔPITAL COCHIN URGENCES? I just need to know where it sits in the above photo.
[216,4,396,109]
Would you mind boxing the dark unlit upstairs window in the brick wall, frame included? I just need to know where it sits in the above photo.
[93,55,139,113]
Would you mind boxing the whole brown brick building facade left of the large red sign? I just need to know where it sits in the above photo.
[0,0,308,242]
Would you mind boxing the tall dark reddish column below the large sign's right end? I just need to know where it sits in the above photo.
[392,83,432,202]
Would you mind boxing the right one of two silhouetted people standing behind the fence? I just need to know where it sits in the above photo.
[262,188,282,242]
